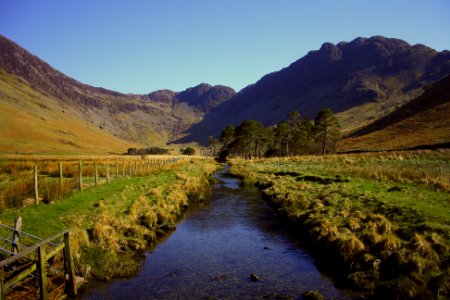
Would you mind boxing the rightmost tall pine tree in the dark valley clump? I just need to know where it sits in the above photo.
[314,108,340,155]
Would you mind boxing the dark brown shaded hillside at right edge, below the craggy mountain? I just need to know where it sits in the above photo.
[340,75,450,151]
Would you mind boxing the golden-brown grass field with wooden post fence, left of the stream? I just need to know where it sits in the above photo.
[0,156,183,210]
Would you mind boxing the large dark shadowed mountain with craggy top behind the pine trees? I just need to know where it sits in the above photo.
[179,36,450,142]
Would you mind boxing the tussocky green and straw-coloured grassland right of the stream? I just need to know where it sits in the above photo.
[230,151,450,299]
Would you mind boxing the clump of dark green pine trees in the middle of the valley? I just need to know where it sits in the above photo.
[213,108,340,160]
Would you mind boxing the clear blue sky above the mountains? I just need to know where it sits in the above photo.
[0,0,450,93]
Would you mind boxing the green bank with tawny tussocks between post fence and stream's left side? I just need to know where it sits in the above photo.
[0,159,217,280]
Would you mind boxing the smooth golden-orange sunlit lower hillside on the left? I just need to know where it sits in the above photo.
[0,69,139,154]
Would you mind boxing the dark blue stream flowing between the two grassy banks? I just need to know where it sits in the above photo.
[82,171,351,299]
